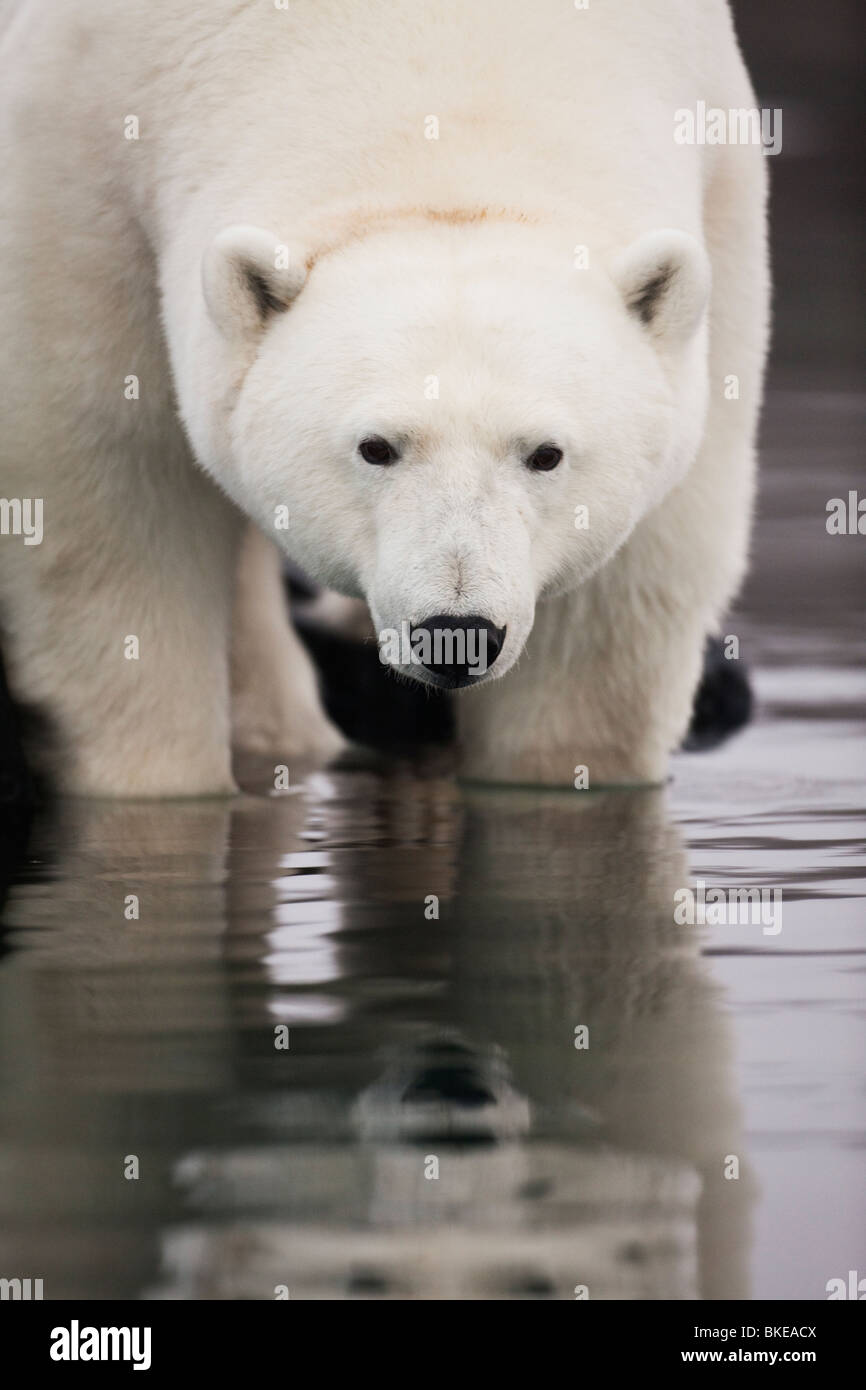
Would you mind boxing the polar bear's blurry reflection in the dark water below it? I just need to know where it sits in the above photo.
[0,767,751,1298]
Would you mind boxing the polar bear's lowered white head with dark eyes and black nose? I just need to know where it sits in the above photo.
[188,218,709,687]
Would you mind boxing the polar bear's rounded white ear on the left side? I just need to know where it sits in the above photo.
[202,227,307,338]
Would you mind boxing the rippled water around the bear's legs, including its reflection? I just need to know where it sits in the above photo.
[0,379,866,1300]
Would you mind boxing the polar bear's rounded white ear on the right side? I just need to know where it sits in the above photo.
[612,228,710,345]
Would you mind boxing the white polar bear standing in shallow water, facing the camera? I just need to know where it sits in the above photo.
[0,0,769,796]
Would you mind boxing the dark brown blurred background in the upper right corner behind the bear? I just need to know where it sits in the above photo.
[733,0,866,388]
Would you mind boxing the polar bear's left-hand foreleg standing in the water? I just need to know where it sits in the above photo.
[3,461,244,796]
